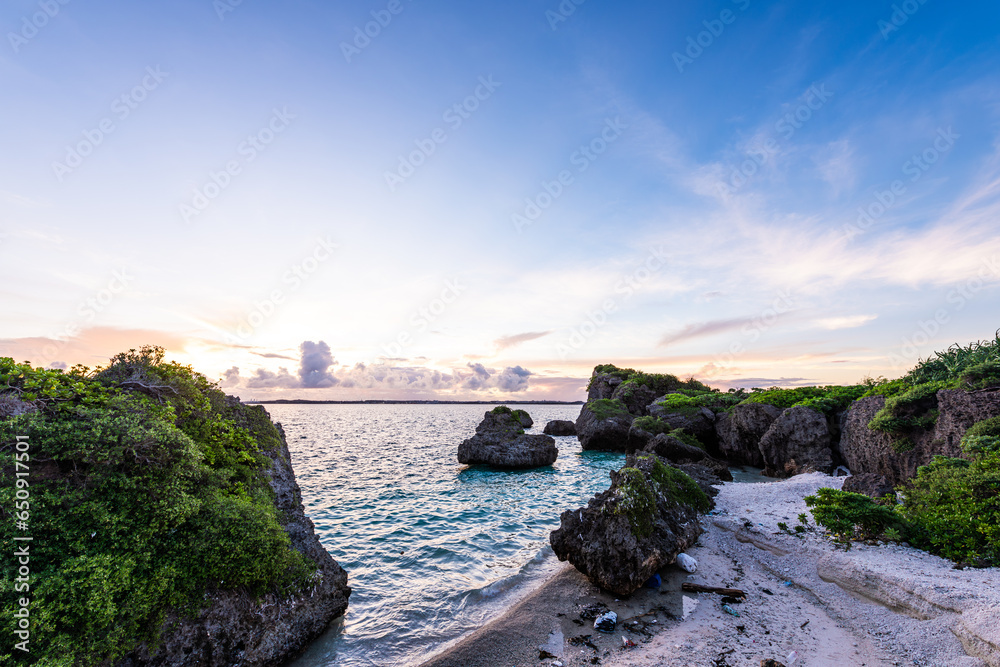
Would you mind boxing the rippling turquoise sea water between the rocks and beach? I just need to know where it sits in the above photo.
[265,404,624,667]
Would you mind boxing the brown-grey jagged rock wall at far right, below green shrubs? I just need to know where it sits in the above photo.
[839,389,1000,486]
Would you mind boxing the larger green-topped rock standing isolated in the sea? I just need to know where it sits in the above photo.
[458,411,559,469]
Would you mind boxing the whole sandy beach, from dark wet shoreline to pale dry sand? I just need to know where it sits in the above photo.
[423,473,1000,667]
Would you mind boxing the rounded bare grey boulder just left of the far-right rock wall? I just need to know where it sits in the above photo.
[759,405,833,477]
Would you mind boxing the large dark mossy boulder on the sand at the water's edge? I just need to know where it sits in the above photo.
[550,455,712,595]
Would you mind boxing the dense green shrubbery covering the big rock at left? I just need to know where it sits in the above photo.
[0,348,316,666]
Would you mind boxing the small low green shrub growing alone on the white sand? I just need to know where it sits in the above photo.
[805,488,901,542]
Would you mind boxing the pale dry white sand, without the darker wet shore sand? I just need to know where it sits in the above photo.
[600,473,1000,667]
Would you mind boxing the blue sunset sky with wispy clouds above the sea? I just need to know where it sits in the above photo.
[0,0,1000,402]
